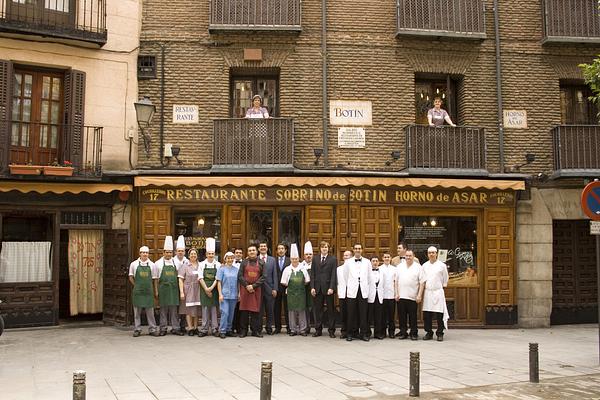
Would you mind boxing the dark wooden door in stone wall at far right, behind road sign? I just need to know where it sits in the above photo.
[550,220,598,324]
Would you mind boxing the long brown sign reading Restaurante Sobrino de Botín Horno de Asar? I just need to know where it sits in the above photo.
[141,186,515,206]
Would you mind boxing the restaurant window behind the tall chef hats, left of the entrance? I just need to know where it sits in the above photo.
[175,209,221,260]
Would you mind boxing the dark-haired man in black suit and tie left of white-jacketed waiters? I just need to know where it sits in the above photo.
[310,240,338,338]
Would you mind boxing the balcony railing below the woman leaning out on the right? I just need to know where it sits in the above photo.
[404,125,488,175]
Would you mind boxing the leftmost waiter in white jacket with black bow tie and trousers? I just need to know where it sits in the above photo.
[344,243,371,342]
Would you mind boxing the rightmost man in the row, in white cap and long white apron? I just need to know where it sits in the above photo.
[421,246,449,342]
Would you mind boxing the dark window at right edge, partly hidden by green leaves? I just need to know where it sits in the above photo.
[560,83,598,125]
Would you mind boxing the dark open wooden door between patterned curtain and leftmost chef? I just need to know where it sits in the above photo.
[102,229,132,325]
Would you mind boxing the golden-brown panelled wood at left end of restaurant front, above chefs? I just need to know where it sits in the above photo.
[141,205,171,261]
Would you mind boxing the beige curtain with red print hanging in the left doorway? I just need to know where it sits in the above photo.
[69,229,104,315]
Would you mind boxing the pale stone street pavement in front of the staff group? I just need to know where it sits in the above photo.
[0,325,600,400]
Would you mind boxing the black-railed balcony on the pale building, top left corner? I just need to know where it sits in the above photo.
[0,0,107,47]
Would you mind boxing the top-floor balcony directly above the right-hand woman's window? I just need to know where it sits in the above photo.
[396,0,485,39]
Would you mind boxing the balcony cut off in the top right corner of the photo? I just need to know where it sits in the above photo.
[542,0,600,43]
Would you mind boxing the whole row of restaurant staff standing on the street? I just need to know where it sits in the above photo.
[129,236,448,341]
